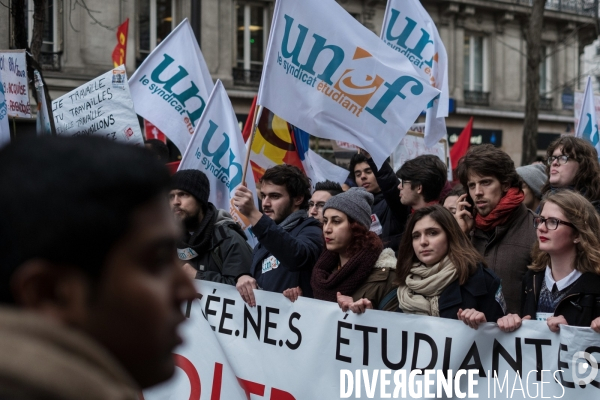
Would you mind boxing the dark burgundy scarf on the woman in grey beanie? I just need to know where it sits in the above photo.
[310,232,383,302]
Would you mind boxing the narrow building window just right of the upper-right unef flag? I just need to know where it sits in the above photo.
[464,34,488,92]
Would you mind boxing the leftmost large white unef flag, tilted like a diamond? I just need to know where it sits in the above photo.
[129,19,214,154]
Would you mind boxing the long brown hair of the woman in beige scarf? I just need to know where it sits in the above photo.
[395,205,485,286]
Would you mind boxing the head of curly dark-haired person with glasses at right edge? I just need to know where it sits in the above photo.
[542,136,600,212]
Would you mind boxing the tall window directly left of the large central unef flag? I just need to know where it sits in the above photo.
[233,1,269,84]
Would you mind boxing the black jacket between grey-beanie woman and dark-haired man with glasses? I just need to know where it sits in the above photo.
[368,159,410,252]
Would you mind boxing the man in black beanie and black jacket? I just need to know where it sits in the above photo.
[169,169,252,285]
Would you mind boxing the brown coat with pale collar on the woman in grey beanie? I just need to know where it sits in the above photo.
[352,249,398,311]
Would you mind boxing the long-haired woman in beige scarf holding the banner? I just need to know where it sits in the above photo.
[340,205,505,329]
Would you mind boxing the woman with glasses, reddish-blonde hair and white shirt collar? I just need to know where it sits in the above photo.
[498,191,600,332]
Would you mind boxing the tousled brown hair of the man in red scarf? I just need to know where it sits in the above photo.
[456,144,522,189]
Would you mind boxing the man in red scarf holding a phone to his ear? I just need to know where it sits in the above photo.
[454,144,537,314]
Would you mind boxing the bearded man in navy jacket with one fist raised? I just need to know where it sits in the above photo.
[233,165,323,306]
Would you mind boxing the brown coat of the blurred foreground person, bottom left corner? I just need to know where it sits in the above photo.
[0,307,139,400]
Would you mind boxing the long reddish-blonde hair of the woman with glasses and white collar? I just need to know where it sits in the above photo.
[529,190,600,275]
